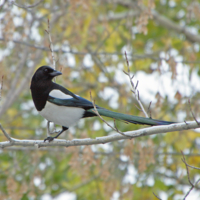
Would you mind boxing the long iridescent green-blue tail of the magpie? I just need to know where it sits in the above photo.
[87,108,176,126]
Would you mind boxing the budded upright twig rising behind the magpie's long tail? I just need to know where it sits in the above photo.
[123,51,149,118]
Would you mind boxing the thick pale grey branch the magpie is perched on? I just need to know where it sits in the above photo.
[0,121,200,148]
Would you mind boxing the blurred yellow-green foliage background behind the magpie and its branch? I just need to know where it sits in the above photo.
[0,0,200,200]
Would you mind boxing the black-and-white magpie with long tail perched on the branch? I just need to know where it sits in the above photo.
[30,65,175,142]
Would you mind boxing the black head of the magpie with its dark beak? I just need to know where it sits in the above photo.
[32,66,62,81]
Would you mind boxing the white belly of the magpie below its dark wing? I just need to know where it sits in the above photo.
[39,101,85,127]
